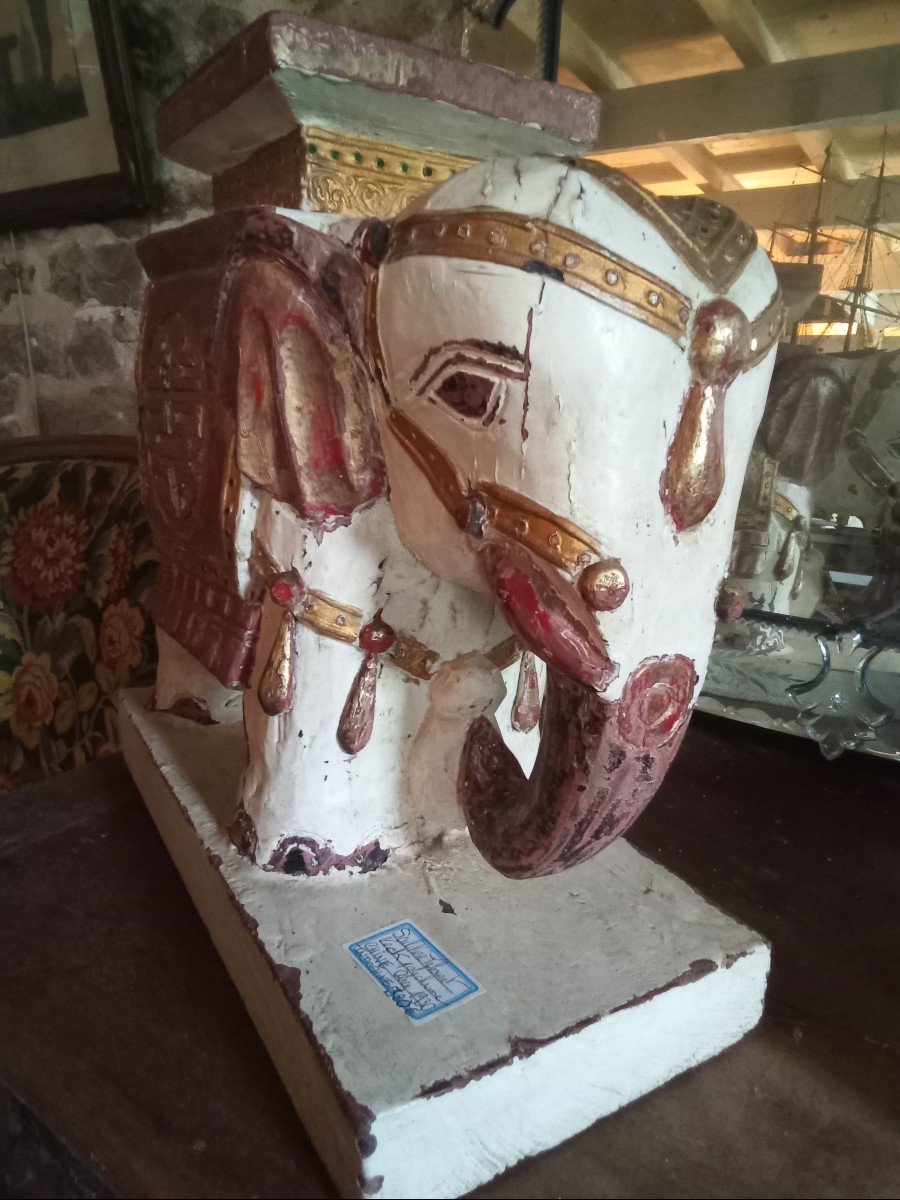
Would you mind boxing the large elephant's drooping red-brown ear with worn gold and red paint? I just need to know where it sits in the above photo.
[216,212,384,524]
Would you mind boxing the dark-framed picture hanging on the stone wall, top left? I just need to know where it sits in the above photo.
[0,0,149,229]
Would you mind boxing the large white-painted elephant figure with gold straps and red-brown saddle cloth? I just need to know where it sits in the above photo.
[137,158,781,878]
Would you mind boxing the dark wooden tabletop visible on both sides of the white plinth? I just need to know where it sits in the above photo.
[0,715,900,1198]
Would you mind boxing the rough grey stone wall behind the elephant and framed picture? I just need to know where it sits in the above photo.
[0,0,463,440]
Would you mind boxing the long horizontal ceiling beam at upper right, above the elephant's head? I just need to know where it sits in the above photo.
[598,46,900,152]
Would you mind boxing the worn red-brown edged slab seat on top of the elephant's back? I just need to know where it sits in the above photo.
[156,12,600,174]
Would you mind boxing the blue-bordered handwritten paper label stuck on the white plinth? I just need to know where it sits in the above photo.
[347,920,484,1021]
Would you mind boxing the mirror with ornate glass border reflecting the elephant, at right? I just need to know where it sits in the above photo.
[698,333,900,761]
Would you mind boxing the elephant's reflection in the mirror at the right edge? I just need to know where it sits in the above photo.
[732,350,900,623]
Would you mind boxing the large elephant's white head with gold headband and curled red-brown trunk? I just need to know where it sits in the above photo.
[370,158,781,877]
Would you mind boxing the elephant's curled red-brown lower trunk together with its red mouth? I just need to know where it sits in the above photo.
[460,547,697,878]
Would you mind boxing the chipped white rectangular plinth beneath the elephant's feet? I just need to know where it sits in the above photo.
[120,692,769,1198]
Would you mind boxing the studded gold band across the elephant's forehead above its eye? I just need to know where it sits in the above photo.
[385,211,691,341]
